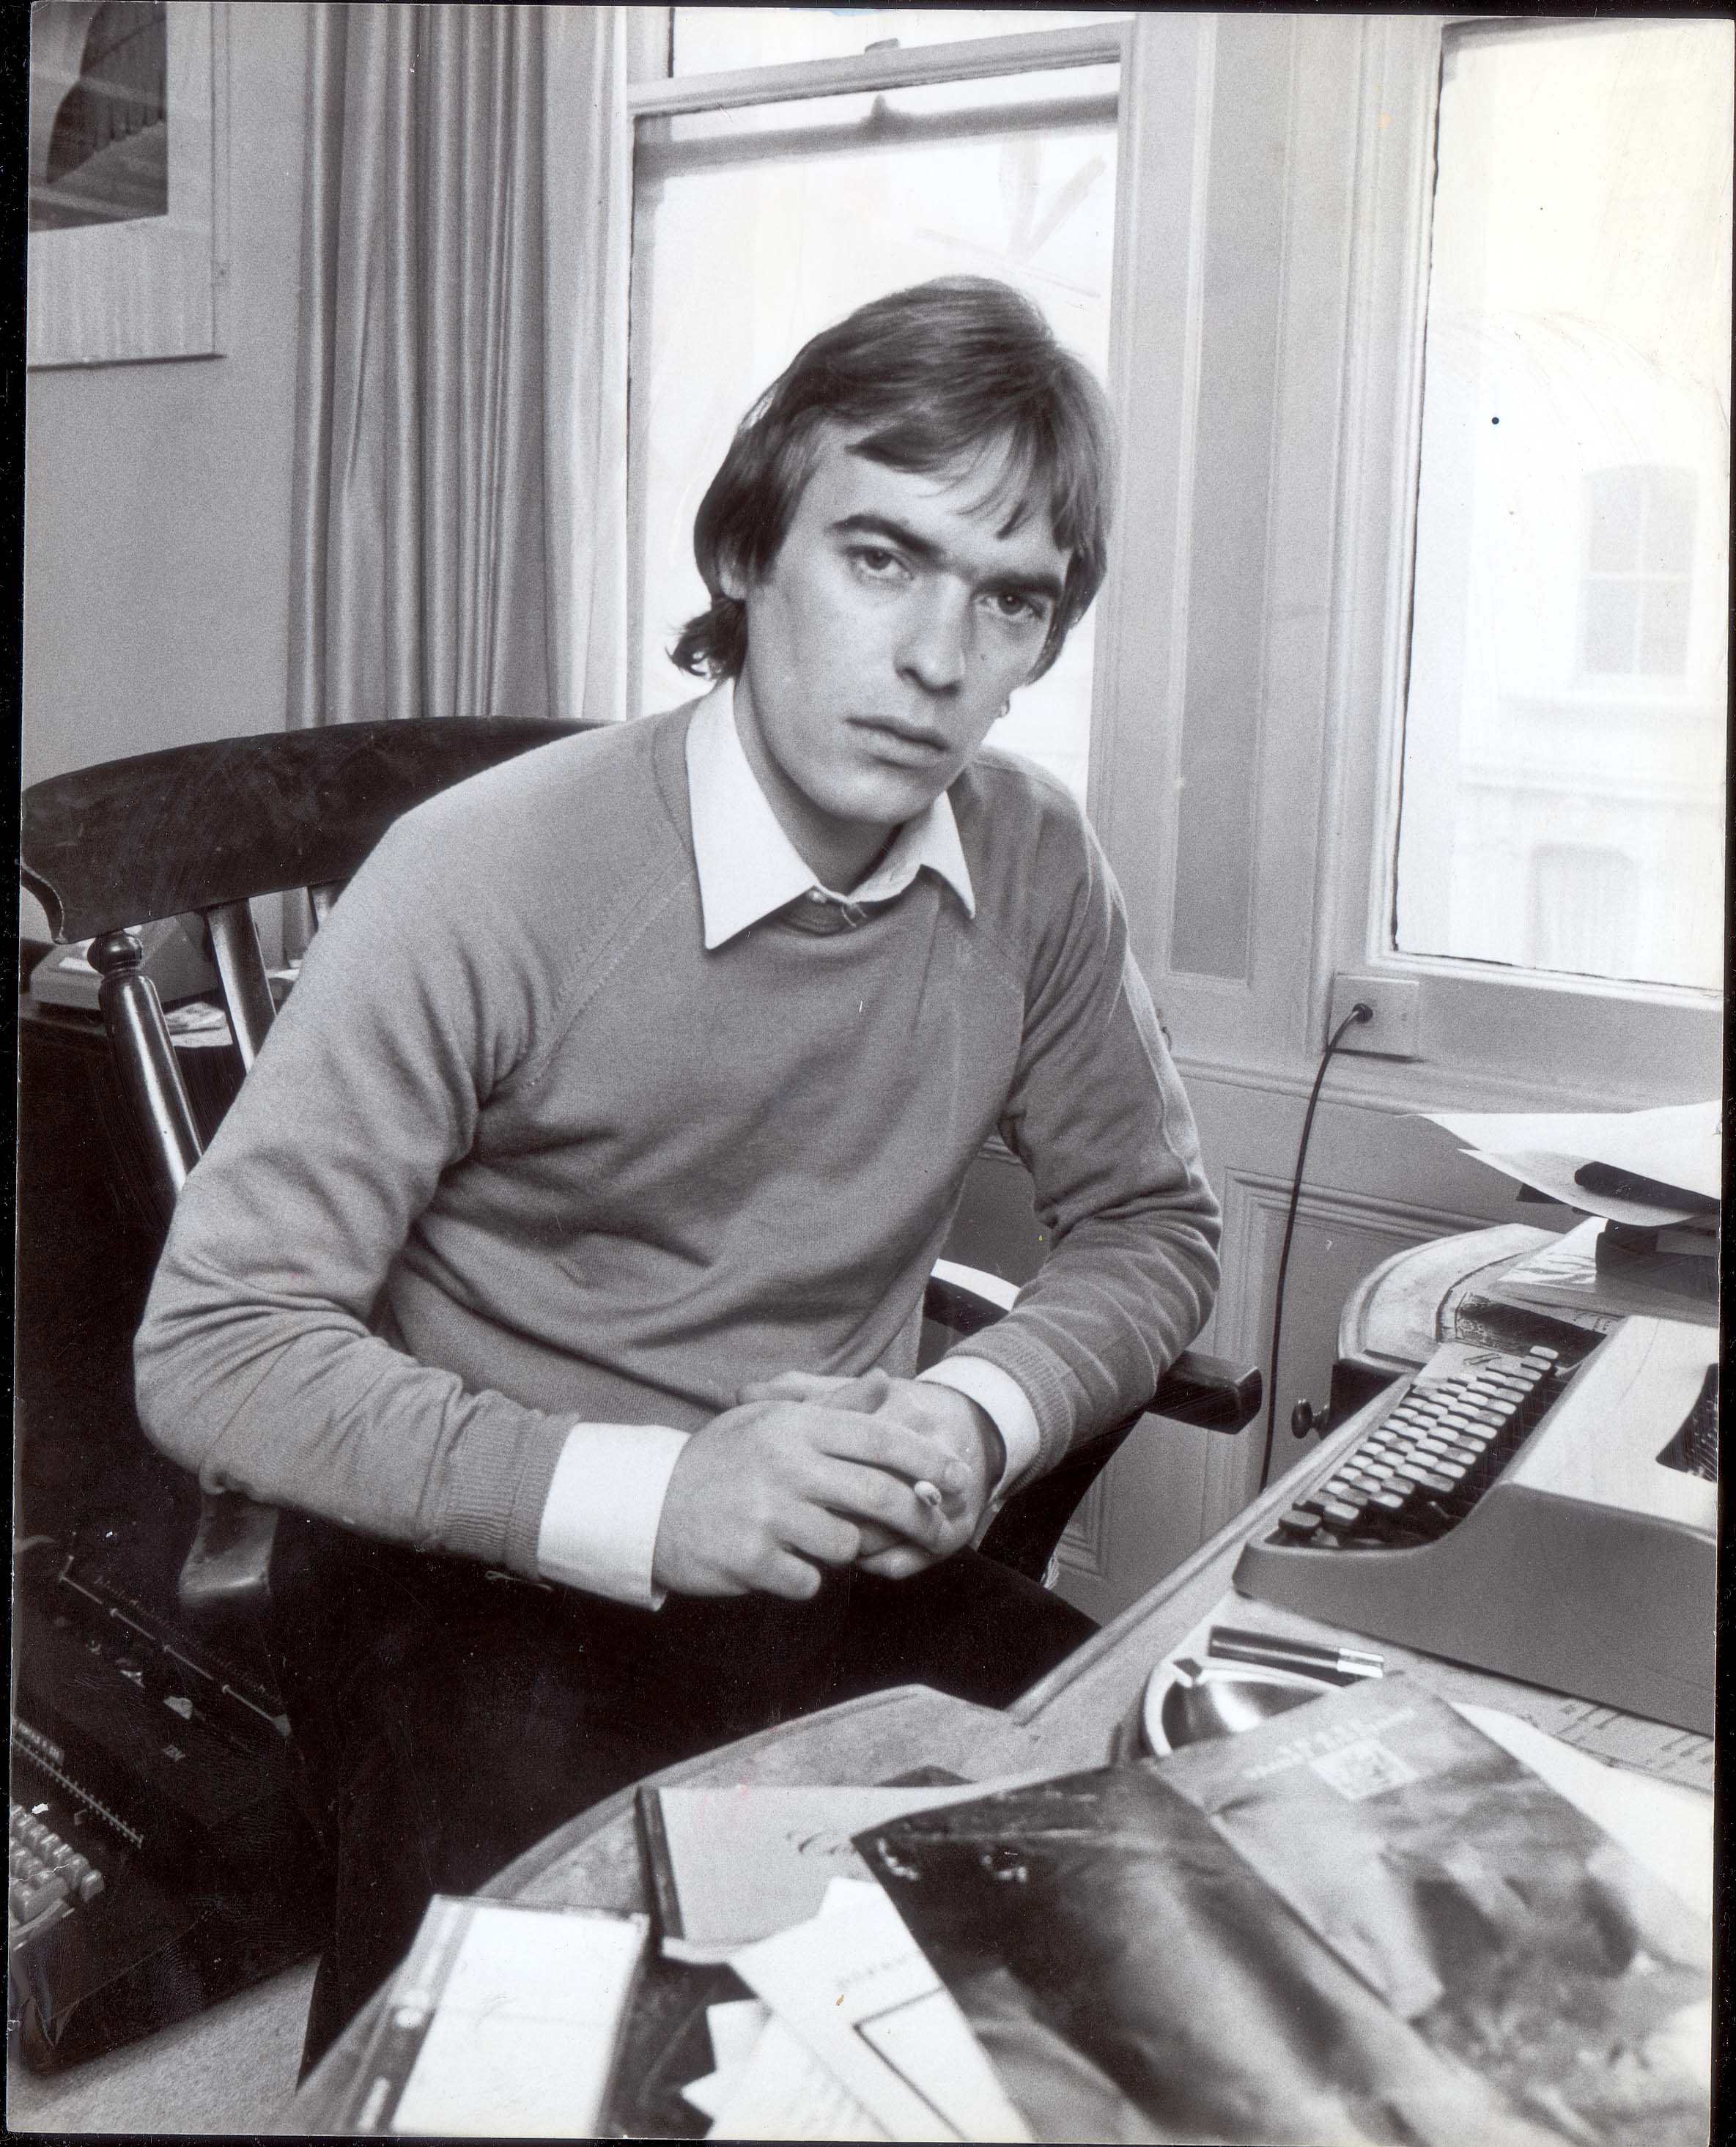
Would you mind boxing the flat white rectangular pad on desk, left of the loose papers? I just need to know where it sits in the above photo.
[344,1893,650,2138]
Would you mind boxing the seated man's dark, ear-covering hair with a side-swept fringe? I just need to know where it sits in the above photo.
[670,275,1112,679]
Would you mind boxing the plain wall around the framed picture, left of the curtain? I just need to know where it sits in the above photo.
[19,0,307,938]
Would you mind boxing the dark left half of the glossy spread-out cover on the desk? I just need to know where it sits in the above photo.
[858,1763,1560,2147]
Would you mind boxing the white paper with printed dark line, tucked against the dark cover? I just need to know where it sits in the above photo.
[732,1879,1030,2140]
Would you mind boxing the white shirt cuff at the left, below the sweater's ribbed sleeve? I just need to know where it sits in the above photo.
[536,1404,690,1611]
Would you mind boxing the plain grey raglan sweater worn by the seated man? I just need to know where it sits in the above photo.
[135,709,1216,1574]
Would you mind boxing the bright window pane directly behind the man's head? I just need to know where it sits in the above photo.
[633,69,1116,799]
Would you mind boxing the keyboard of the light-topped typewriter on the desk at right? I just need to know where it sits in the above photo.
[1272,1344,1560,1550]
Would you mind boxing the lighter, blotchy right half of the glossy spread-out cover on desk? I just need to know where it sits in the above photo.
[1163,1677,1710,2147]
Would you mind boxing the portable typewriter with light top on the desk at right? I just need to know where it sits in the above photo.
[1234,1318,1717,1734]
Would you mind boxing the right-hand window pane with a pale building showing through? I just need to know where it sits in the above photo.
[1395,21,1732,990]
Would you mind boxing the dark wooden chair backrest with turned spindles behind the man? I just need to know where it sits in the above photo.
[19,720,590,1213]
